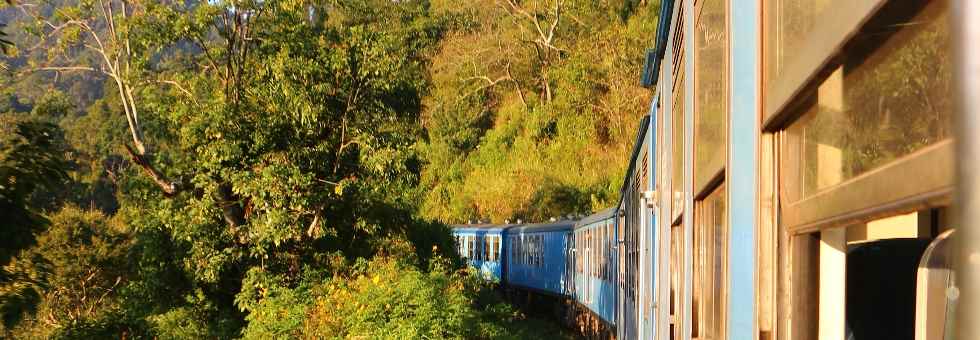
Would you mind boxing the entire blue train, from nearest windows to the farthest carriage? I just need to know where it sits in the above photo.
[454,0,980,340]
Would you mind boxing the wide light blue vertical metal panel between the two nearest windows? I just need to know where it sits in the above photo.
[726,0,762,339]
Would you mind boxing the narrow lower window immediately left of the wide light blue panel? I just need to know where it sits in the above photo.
[691,183,728,339]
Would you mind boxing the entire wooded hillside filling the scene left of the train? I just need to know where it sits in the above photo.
[0,0,657,339]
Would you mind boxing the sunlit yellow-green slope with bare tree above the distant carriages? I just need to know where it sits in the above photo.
[422,0,658,223]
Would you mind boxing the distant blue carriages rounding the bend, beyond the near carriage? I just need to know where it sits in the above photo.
[453,208,617,332]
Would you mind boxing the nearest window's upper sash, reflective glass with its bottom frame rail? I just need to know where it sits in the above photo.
[781,1,953,231]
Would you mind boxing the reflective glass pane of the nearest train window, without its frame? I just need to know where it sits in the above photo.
[784,1,952,202]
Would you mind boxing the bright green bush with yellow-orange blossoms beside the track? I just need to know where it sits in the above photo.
[241,252,576,339]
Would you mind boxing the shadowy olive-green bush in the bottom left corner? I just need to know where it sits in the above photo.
[0,206,131,338]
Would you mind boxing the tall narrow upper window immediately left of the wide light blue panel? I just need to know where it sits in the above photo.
[694,0,728,191]
